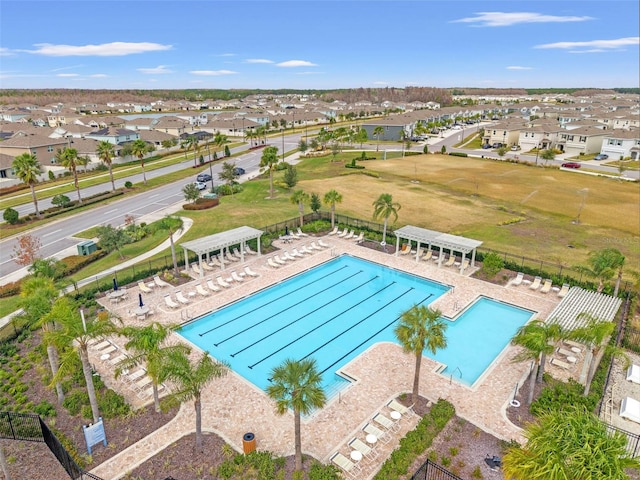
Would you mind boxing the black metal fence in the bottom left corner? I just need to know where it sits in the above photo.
[0,412,102,480]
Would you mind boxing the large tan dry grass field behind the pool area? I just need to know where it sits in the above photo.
[296,155,640,270]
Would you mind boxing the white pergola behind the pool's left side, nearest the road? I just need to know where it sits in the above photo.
[180,226,264,278]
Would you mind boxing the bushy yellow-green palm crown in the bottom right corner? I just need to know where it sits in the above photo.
[502,407,640,480]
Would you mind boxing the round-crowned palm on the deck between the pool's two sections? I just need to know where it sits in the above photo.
[393,305,447,403]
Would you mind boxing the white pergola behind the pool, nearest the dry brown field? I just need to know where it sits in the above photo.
[393,225,482,274]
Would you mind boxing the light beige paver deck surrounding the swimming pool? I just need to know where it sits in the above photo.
[91,236,560,480]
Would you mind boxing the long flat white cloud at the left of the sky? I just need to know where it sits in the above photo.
[25,42,172,57]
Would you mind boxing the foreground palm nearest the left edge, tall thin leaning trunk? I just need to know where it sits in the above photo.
[20,277,64,405]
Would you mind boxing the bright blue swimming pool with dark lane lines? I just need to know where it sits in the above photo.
[178,255,531,397]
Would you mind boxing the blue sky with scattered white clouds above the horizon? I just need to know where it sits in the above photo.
[0,0,640,89]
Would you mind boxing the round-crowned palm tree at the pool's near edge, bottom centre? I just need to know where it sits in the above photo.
[267,358,326,471]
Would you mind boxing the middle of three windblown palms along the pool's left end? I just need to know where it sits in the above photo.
[115,322,191,412]
